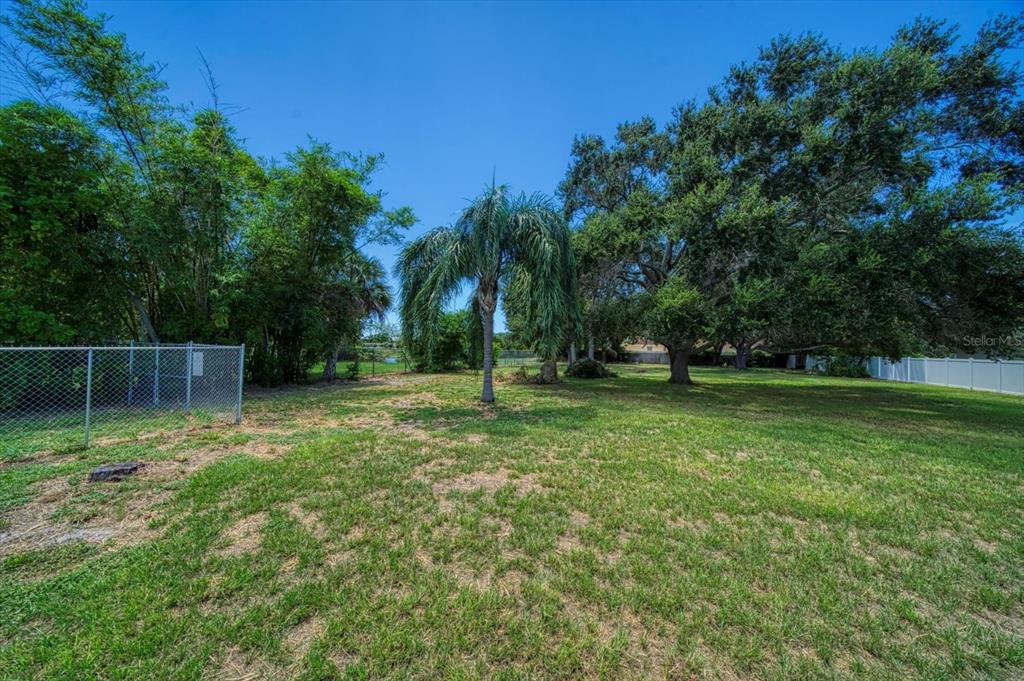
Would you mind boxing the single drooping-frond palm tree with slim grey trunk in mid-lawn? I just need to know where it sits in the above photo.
[397,184,575,402]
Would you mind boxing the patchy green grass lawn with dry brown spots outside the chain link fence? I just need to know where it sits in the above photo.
[0,368,1024,679]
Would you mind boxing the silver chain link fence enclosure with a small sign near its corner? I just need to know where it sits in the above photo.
[0,343,245,456]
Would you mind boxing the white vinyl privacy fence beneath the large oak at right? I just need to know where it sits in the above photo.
[805,356,1024,395]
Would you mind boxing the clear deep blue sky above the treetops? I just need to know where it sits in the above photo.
[6,0,1021,329]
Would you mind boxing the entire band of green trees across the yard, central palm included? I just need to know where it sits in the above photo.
[0,0,1024,399]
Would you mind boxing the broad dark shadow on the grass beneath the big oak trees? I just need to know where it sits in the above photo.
[559,369,1024,472]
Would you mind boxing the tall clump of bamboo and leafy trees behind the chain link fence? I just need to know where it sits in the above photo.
[0,0,415,384]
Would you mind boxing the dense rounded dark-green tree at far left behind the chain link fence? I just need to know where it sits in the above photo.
[0,101,120,343]
